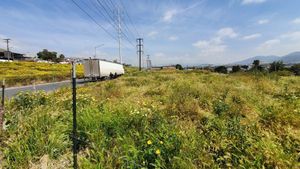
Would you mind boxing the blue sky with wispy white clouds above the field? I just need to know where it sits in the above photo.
[0,0,300,66]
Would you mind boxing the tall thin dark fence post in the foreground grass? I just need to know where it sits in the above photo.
[72,61,78,169]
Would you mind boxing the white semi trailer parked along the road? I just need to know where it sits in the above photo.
[83,59,125,80]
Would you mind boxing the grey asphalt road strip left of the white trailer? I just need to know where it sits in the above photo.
[1,79,85,98]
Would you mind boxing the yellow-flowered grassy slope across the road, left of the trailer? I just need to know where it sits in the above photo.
[0,62,83,86]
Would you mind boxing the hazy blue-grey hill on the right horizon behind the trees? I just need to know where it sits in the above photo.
[231,52,300,65]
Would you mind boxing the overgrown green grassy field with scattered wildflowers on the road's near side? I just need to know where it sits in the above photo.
[0,70,300,169]
